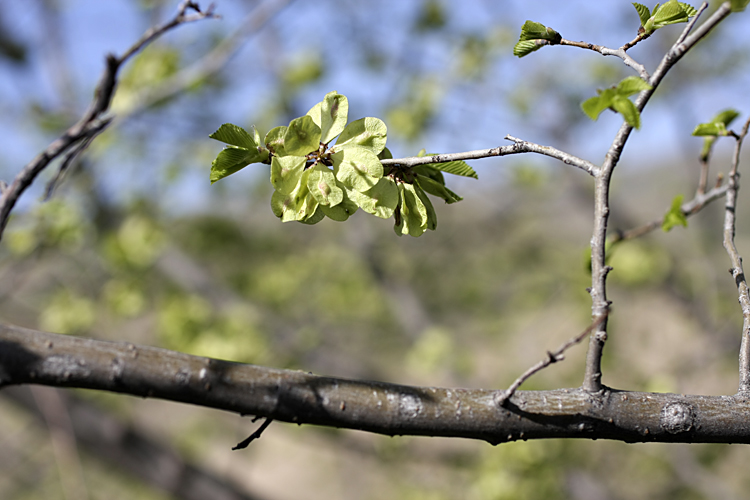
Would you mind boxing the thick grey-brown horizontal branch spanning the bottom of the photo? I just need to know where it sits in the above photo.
[0,326,750,444]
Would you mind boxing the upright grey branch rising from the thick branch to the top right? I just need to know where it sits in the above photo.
[582,2,731,392]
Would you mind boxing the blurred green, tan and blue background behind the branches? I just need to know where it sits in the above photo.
[0,0,750,500]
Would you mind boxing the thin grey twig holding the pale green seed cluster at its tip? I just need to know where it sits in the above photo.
[380,135,598,176]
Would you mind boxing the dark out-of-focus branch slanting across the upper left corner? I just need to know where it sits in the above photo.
[0,1,215,239]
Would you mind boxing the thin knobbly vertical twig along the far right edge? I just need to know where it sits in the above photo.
[724,118,750,393]
